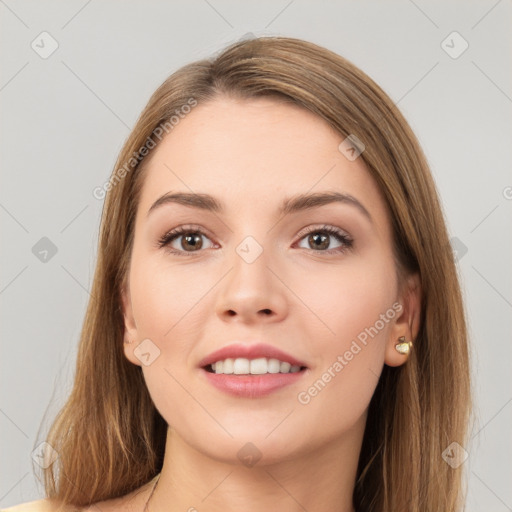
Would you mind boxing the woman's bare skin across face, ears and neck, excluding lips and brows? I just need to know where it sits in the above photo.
[99,97,420,512]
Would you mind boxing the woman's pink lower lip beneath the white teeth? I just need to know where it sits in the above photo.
[201,368,307,398]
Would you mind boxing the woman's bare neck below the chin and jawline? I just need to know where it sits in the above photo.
[148,417,366,512]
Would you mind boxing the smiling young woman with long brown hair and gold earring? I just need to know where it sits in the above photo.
[8,37,471,512]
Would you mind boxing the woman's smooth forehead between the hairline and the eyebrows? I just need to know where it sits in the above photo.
[139,97,387,230]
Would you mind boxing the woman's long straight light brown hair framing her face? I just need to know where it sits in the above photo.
[38,37,472,512]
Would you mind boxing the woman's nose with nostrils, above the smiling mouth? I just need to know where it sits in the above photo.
[217,241,288,324]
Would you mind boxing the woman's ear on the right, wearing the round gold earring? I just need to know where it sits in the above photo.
[384,274,421,366]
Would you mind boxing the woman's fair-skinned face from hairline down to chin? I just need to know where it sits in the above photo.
[123,98,409,463]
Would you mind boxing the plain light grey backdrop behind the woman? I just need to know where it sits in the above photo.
[0,0,512,512]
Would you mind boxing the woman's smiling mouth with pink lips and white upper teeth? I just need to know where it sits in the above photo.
[199,343,308,398]
